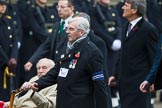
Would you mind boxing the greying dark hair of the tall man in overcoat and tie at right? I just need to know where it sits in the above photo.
[125,0,146,16]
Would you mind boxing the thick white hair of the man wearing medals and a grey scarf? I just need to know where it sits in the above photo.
[68,17,90,33]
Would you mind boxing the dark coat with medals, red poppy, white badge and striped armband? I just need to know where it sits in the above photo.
[36,38,108,108]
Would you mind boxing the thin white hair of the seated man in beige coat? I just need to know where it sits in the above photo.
[36,58,55,69]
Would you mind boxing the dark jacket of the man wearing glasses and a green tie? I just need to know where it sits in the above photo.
[29,22,67,64]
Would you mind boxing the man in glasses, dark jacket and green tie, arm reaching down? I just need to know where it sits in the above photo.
[24,0,74,70]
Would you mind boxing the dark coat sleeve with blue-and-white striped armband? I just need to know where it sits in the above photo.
[88,48,108,108]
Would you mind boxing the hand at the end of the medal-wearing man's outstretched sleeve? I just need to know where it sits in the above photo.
[21,82,38,91]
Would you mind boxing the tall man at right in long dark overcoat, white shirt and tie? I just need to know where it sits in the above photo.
[109,0,159,108]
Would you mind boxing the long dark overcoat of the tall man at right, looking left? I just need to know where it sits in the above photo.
[115,19,159,108]
